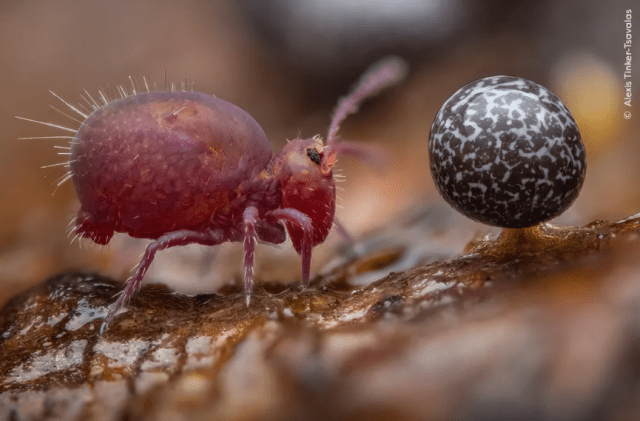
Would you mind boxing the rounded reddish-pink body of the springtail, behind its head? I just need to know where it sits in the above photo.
[71,92,282,244]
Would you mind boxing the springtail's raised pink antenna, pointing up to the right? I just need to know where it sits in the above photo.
[326,56,408,146]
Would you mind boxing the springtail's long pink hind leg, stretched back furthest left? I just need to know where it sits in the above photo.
[100,230,224,334]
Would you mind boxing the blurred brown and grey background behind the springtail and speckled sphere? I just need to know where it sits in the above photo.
[0,0,640,303]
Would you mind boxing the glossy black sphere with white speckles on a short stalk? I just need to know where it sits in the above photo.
[429,76,586,228]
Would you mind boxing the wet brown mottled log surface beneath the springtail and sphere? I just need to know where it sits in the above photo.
[0,205,640,420]
